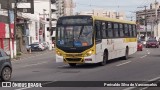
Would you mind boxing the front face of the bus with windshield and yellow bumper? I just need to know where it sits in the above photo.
[56,16,95,66]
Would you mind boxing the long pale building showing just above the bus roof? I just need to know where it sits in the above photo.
[77,9,126,19]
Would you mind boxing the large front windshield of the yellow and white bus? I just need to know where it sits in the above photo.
[56,25,93,47]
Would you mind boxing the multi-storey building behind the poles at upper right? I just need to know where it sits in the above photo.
[136,2,160,38]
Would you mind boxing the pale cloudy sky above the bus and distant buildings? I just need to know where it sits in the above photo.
[73,0,160,17]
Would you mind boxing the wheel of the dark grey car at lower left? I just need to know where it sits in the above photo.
[1,67,12,81]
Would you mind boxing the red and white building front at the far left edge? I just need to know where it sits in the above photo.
[0,9,14,58]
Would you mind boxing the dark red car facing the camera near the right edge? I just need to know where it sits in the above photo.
[146,39,159,48]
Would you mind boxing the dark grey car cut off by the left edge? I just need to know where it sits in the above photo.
[0,49,12,81]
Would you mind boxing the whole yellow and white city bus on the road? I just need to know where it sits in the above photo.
[55,15,137,66]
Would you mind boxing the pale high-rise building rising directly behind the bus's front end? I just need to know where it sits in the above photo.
[56,0,74,18]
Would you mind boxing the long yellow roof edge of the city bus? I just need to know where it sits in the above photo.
[60,15,136,24]
